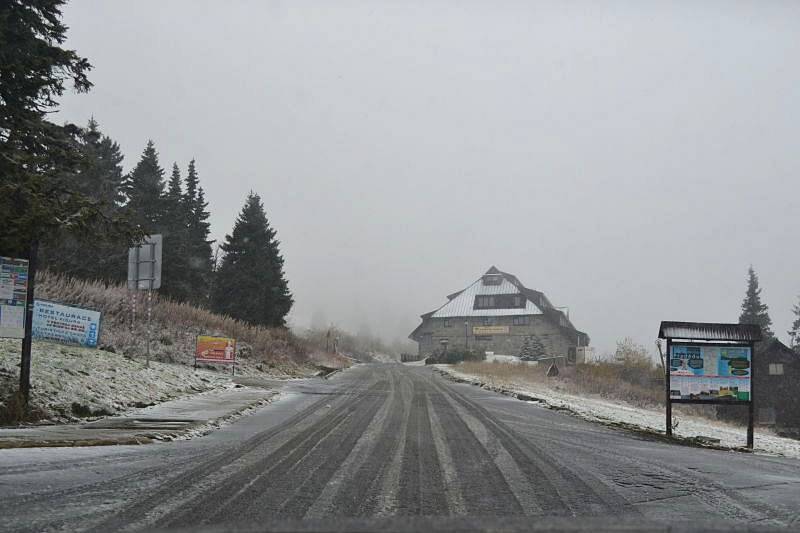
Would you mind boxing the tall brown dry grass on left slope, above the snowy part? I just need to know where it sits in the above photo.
[36,272,322,374]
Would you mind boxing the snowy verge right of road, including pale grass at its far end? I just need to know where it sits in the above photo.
[436,363,800,458]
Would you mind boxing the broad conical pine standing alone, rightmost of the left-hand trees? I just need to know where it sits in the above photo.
[212,192,294,326]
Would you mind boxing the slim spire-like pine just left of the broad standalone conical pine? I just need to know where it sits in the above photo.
[182,159,214,305]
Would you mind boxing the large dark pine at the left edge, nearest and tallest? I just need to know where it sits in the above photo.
[0,0,137,256]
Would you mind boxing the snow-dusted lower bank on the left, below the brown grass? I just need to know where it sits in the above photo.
[0,339,231,422]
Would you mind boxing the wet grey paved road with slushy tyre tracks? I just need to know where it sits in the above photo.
[0,364,800,531]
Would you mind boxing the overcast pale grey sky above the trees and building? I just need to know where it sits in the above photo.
[58,0,800,351]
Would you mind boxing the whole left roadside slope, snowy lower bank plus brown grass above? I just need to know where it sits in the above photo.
[0,272,349,423]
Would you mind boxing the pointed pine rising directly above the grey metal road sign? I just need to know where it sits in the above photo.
[124,140,164,233]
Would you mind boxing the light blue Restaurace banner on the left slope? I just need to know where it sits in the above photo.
[31,300,101,348]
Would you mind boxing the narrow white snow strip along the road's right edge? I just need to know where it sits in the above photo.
[434,365,800,458]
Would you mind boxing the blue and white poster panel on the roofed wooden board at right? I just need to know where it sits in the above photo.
[669,344,752,402]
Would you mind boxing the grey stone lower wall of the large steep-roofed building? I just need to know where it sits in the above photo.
[419,315,574,357]
